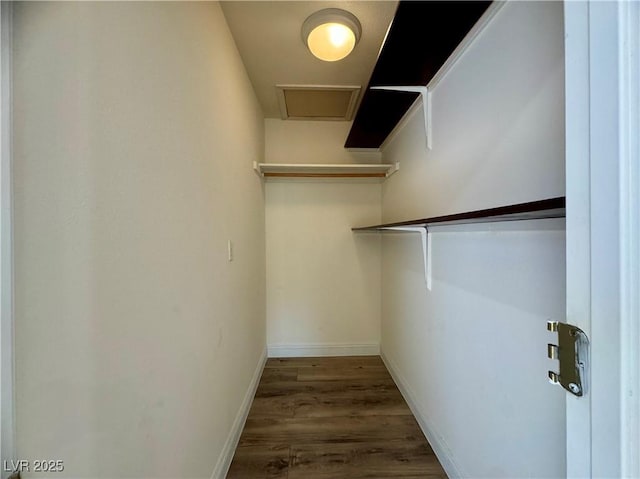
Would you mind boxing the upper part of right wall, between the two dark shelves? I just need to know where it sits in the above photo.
[383,2,564,219]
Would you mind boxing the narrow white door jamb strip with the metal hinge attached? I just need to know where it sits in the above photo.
[564,2,591,478]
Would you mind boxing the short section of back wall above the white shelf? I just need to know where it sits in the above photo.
[265,118,381,164]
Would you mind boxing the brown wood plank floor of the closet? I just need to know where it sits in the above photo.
[227,356,447,479]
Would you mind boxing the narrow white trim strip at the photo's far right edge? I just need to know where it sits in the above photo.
[619,2,640,478]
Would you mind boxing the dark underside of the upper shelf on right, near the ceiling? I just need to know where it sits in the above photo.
[344,0,491,148]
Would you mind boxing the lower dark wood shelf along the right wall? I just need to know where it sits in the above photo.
[351,196,566,231]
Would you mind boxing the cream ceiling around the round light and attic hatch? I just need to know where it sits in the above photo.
[221,0,398,118]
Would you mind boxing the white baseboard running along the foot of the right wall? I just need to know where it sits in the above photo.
[380,351,470,479]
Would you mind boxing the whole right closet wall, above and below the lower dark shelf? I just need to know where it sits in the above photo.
[382,2,566,478]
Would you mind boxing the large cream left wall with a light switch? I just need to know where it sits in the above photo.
[13,2,265,478]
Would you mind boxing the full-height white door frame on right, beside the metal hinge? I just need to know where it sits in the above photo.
[564,1,640,477]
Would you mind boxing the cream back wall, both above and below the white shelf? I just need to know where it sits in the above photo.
[266,120,381,356]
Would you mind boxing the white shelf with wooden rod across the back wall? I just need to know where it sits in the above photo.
[253,162,400,180]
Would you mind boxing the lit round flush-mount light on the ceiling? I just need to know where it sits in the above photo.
[302,8,361,62]
